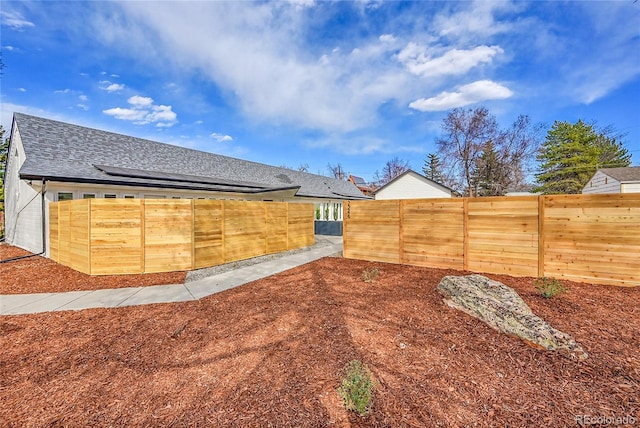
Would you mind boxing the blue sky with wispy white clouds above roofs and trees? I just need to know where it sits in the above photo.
[1,0,640,180]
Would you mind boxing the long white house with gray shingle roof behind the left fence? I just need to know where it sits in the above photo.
[5,113,366,254]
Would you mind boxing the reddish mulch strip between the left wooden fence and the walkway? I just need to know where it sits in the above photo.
[0,243,186,294]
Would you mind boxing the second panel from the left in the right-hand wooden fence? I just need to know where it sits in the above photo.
[400,199,464,269]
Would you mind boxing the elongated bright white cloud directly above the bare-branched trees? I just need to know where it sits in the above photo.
[409,80,513,111]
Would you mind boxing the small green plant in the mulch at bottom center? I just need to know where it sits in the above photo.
[338,360,373,416]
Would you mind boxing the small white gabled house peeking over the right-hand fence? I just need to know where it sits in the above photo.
[375,170,453,200]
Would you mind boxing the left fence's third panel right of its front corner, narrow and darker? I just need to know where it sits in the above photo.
[193,199,224,269]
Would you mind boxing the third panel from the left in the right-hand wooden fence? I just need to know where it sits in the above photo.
[467,196,538,276]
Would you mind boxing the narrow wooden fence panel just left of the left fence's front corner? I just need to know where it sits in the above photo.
[69,199,91,274]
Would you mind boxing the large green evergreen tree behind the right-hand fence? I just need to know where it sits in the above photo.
[534,120,631,194]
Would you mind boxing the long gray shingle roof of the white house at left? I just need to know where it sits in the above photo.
[14,113,364,199]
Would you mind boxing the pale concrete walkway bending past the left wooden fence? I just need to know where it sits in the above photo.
[0,237,342,315]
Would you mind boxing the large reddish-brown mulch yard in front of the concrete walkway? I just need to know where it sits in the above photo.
[0,251,640,427]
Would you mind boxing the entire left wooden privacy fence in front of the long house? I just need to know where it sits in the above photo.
[49,199,314,275]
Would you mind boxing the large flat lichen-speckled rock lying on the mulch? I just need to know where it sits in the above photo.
[438,275,588,360]
